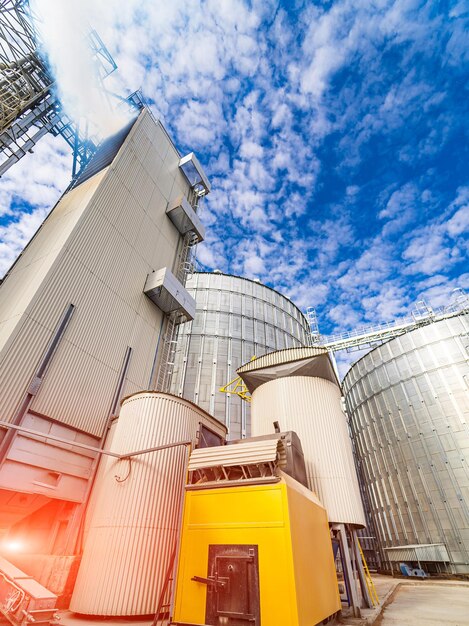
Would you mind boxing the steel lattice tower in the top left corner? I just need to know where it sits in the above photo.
[0,0,122,177]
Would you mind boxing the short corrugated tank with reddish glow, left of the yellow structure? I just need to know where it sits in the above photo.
[70,392,226,616]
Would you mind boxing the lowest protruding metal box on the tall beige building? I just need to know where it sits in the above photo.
[143,267,195,321]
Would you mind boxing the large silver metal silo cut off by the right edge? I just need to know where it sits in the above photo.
[343,313,469,574]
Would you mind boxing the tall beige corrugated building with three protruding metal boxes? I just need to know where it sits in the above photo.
[0,109,208,593]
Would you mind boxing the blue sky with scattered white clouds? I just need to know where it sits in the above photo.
[0,0,469,342]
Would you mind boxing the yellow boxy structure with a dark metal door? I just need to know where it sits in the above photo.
[172,440,341,626]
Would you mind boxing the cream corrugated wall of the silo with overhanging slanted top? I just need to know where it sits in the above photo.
[251,376,365,526]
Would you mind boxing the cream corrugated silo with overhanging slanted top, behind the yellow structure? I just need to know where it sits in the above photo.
[239,348,365,527]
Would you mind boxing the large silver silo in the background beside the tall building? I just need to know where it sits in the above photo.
[171,272,311,439]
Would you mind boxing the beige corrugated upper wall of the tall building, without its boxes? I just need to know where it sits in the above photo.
[0,111,189,437]
